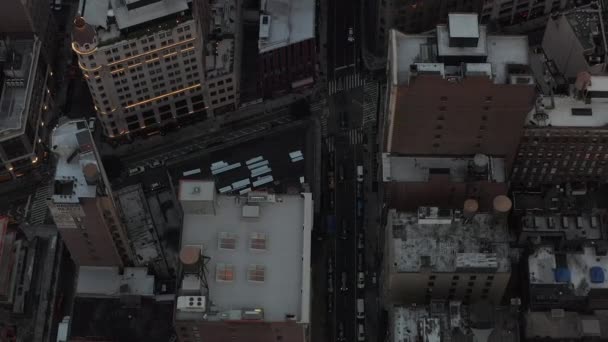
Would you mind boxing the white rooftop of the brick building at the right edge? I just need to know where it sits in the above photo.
[526,94,608,127]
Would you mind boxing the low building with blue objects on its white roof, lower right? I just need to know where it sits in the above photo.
[528,246,608,311]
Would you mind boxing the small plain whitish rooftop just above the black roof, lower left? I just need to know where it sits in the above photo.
[76,266,154,297]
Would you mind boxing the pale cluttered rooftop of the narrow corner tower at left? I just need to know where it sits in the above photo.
[51,120,101,203]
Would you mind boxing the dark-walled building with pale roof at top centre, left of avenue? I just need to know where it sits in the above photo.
[258,0,316,98]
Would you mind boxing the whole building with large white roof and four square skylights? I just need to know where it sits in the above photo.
[175,179,313,342]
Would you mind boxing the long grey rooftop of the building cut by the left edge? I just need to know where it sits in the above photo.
[0,39,40,140]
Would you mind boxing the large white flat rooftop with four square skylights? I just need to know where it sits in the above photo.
[177,193,312,323]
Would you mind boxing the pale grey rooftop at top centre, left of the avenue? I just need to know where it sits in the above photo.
[258,0,315,53]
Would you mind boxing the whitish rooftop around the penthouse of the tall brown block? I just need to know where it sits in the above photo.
[389,25,529,85]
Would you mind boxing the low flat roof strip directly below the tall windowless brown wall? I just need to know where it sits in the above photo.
[382,153,506,183]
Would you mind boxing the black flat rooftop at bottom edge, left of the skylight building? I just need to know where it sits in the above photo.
[70,297,173,342]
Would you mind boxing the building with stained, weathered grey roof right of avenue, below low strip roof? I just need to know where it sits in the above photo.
[383,206,511,305]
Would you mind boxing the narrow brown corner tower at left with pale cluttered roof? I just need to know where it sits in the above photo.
[48,120,134,266]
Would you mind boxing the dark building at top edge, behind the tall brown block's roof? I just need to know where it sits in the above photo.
[364,0,482,56]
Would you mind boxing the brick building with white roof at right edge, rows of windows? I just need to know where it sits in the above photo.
[511,72,608,188]
